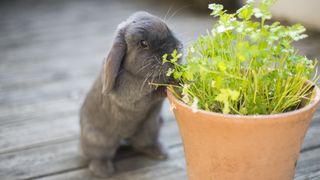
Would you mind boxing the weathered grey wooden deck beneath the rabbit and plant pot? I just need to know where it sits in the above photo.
[0,0,320,180]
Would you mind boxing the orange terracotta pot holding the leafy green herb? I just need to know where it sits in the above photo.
[168,84,320,180]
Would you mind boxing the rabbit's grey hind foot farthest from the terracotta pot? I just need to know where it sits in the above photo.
[89,160,114,177]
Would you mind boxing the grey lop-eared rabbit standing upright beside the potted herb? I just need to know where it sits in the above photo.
[80,12,182,177]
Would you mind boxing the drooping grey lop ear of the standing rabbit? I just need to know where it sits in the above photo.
[102,27,127,93]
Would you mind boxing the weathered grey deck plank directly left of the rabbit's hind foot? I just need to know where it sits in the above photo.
[0,141,85,179]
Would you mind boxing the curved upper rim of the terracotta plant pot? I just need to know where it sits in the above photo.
[167,80,320,121]
